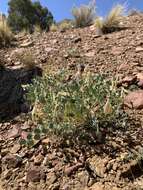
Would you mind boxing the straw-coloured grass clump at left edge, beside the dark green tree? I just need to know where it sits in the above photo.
[0,16,14,47]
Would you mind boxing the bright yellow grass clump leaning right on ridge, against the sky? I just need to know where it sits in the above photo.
[95,5,125,34]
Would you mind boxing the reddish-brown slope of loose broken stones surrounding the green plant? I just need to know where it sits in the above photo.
[0,14,143,190]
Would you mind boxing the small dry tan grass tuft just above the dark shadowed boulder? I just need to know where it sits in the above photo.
[17,50,35,69]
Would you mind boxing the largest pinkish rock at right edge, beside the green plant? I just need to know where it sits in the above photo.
[124,90,143,109]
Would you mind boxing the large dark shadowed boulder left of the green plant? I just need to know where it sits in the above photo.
[0,66,24,120]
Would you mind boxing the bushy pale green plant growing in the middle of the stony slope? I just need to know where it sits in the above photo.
[25,69,121,142]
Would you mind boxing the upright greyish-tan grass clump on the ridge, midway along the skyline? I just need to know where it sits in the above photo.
[72,2,95,27]
